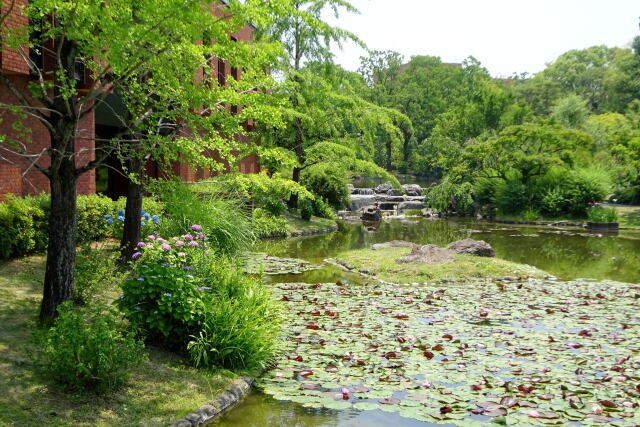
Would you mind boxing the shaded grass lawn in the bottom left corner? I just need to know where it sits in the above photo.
[0,256,232,426]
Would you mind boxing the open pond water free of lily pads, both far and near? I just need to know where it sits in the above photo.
[215,218,640,427]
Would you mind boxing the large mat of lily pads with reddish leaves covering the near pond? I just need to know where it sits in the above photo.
[261,279,640,426]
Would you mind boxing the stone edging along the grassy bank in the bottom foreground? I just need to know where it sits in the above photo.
[170,376,255,427]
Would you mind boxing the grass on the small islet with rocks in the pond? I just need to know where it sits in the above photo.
[338,248,546,283]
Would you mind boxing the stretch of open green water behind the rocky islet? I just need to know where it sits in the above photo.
[257,219,640,283]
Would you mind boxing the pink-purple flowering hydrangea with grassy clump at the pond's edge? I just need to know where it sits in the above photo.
[116,224,280,369]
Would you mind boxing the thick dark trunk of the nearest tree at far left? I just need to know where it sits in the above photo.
[40,157,77,323]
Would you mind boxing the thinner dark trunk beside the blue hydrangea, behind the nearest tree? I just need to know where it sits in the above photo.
[120,155,144,264]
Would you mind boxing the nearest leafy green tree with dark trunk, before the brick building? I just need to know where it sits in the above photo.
[0,0,287,321]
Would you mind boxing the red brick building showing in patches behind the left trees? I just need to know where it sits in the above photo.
[0,0,260,201]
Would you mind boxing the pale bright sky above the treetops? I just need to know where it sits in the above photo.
[325,0,640,77]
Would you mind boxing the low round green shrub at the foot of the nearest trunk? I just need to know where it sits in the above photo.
[35,302,146,393]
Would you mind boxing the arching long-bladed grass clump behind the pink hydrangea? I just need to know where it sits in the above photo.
[156,182,254,255]
